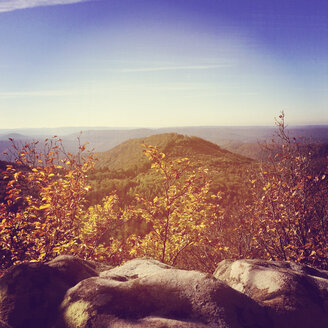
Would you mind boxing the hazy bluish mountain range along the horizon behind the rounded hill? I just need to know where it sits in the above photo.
[0,125,328,158]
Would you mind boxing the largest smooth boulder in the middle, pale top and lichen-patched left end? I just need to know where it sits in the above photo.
[56,259,271,328]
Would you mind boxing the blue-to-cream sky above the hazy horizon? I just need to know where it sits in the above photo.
[0,0,328,129]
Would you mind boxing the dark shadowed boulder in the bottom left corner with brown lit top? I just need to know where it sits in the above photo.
[0,256,109,328]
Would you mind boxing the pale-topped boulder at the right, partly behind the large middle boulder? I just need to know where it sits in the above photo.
[214,260,328,328]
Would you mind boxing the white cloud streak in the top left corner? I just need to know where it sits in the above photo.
[0,0,93,13]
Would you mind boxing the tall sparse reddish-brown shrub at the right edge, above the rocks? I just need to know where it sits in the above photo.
[246,113,328,268]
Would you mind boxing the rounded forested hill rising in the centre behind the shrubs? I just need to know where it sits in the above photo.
[89,133,254,203]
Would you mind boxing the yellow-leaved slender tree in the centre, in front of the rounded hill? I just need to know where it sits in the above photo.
[129,145,216,265]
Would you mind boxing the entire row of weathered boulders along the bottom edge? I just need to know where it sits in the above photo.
[0,256,328,328]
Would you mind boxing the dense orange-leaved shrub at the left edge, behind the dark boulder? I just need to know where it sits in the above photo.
[0,138,94,268]
